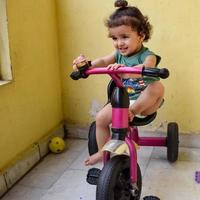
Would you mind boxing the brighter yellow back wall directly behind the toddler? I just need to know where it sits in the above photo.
[57,0,200,133]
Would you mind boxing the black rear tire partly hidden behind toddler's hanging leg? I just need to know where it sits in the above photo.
[88,121,98,156]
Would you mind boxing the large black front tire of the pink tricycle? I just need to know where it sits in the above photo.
[96,155,142,200]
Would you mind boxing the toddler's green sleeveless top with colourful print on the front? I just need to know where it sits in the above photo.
[115,46,161,100]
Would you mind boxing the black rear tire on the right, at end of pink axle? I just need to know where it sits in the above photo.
[167,122,179,163]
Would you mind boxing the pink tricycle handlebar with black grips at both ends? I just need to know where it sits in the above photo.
[70,65,169,80]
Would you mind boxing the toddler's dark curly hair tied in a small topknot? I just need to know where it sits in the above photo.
[105,0,152,41]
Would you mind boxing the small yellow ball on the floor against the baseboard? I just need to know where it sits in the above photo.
[49,137,65,153]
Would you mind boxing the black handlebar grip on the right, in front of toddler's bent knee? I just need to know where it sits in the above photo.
[142,67,169,79]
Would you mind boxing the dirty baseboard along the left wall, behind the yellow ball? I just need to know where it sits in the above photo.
[0,124,64,197]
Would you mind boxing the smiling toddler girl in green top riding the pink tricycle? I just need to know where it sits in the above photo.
[73,0,164,165]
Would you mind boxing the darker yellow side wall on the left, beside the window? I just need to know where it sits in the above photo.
[0,0,63,169]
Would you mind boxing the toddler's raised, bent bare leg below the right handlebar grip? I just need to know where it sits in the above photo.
[130,81,164,115]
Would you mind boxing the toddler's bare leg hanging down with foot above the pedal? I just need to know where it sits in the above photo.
[85,104,112,165]
